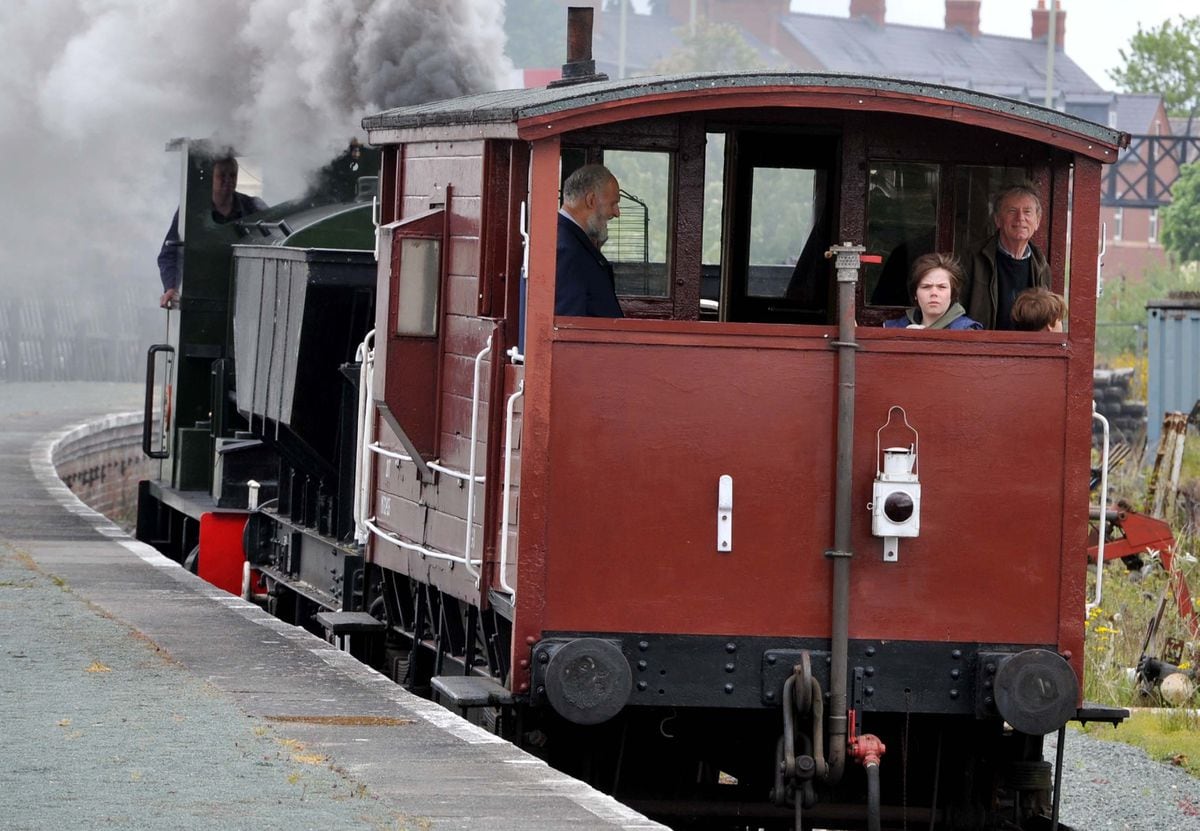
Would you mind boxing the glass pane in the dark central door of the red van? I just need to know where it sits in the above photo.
[746,167,817,298]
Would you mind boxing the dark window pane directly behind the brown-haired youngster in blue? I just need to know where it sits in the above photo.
[863,162,940,306]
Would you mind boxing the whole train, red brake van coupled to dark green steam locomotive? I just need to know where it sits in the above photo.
[138,16,1127,830]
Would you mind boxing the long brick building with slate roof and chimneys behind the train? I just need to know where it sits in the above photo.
[513,0,1171,279]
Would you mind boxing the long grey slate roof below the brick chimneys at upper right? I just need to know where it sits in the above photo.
[781,13,1110,101]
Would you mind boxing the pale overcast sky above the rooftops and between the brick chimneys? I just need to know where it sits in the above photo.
[792,0,1180,89]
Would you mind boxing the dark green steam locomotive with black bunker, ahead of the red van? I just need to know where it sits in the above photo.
[137,139,378,602]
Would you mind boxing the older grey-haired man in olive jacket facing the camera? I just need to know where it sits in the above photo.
[966,185,1050,329]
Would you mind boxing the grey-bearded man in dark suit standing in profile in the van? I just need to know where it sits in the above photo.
[554,165,624,317]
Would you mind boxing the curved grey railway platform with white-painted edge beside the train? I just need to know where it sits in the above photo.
[0,384,664,831]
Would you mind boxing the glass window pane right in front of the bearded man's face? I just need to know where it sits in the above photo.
[604,150,671,297]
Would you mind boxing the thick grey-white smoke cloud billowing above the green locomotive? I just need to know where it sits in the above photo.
[0,0,509,324]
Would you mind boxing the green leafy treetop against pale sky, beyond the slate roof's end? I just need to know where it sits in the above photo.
[1109,14,1200,115]
